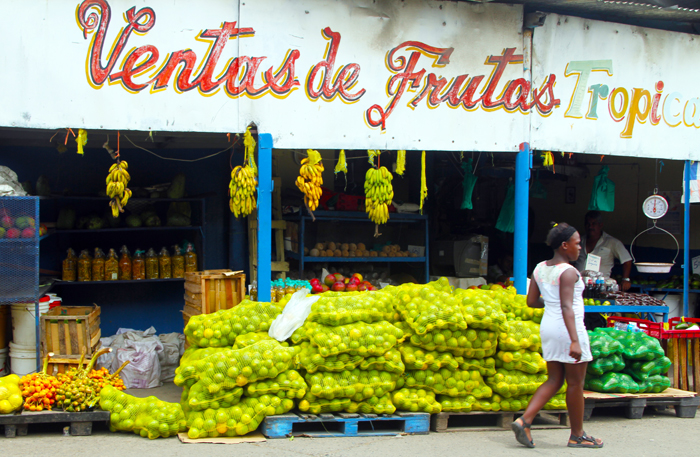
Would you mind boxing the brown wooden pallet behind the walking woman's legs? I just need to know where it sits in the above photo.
[430,410,570,432]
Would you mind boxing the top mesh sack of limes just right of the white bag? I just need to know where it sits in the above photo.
[307,290,396,326]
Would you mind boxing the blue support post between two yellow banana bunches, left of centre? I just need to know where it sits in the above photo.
[258,133,274,302]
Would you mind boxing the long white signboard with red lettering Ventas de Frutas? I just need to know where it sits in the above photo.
[0,0,528,151]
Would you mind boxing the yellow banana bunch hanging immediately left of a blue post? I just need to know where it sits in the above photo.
[228,127,258,218]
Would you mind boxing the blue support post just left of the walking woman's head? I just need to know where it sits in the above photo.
[513,143,532,294]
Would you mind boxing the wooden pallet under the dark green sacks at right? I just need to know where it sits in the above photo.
[583,388,700,421]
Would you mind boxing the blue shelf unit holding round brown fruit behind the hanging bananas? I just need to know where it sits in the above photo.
[284,210,430,283]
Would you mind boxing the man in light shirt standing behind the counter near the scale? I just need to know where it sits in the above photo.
[574,211,632,291]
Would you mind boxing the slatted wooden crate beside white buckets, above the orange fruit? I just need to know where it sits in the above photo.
[41,305,102,360]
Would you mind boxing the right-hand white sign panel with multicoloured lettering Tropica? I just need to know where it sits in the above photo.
[531,14,700,160]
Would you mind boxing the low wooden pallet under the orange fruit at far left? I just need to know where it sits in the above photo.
[0,411,110,438]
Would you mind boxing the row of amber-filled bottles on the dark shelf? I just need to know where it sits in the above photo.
[62,243,197,281]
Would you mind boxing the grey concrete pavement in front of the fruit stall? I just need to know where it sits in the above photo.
[0,384,700,457]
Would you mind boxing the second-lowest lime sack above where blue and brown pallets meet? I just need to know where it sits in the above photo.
[397,368,491,398]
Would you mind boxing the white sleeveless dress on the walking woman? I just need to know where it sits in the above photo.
[532,261,593,363]
